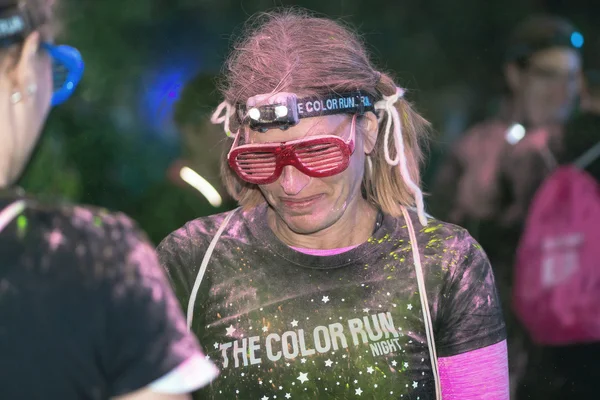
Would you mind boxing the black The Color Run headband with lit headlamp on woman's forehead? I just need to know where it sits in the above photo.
[238,91,375,132]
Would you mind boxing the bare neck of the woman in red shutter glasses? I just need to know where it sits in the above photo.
[267,197,378,250]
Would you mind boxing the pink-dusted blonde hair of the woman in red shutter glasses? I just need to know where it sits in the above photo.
[221,9,429,216]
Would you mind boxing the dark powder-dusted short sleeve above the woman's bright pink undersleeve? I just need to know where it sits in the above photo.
[434,231,506,357]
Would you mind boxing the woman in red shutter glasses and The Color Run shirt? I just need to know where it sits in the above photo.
[159,11,508,400]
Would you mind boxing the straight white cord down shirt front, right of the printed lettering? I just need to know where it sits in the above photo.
[402,207,442,400]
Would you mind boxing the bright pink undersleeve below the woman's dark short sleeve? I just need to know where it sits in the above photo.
[438,340,509,400]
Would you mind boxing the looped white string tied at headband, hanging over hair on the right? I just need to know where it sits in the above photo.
[375,88,427,226]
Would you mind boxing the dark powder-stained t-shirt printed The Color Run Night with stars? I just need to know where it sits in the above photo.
[159,206,505,400]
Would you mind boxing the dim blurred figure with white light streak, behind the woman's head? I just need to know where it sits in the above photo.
[130,73,235,243]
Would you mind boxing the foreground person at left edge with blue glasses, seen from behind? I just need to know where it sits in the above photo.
[0,0,217,400]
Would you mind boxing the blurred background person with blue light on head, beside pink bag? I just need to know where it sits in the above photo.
[430,15,583,393]
